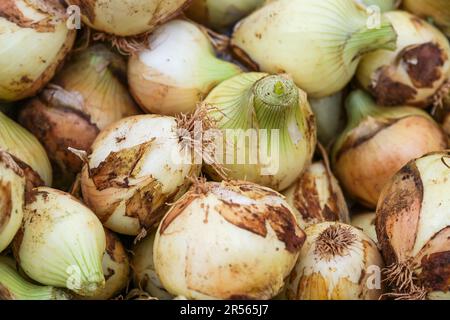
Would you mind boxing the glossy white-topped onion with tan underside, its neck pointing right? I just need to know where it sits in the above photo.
[128,20,241,115]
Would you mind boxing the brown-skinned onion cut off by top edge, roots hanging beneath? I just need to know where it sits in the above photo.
[67,0,191,37]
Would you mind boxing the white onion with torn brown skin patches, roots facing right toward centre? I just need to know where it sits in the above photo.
[81,115,202,235]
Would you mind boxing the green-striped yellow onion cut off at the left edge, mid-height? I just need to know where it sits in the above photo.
[0,112,52,186]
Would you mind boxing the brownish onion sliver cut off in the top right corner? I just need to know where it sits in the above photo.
[403,0,450,37]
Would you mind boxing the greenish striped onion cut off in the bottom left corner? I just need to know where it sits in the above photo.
[0,256,70,300]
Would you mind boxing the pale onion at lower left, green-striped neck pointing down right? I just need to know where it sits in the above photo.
[13,187,106,296]
